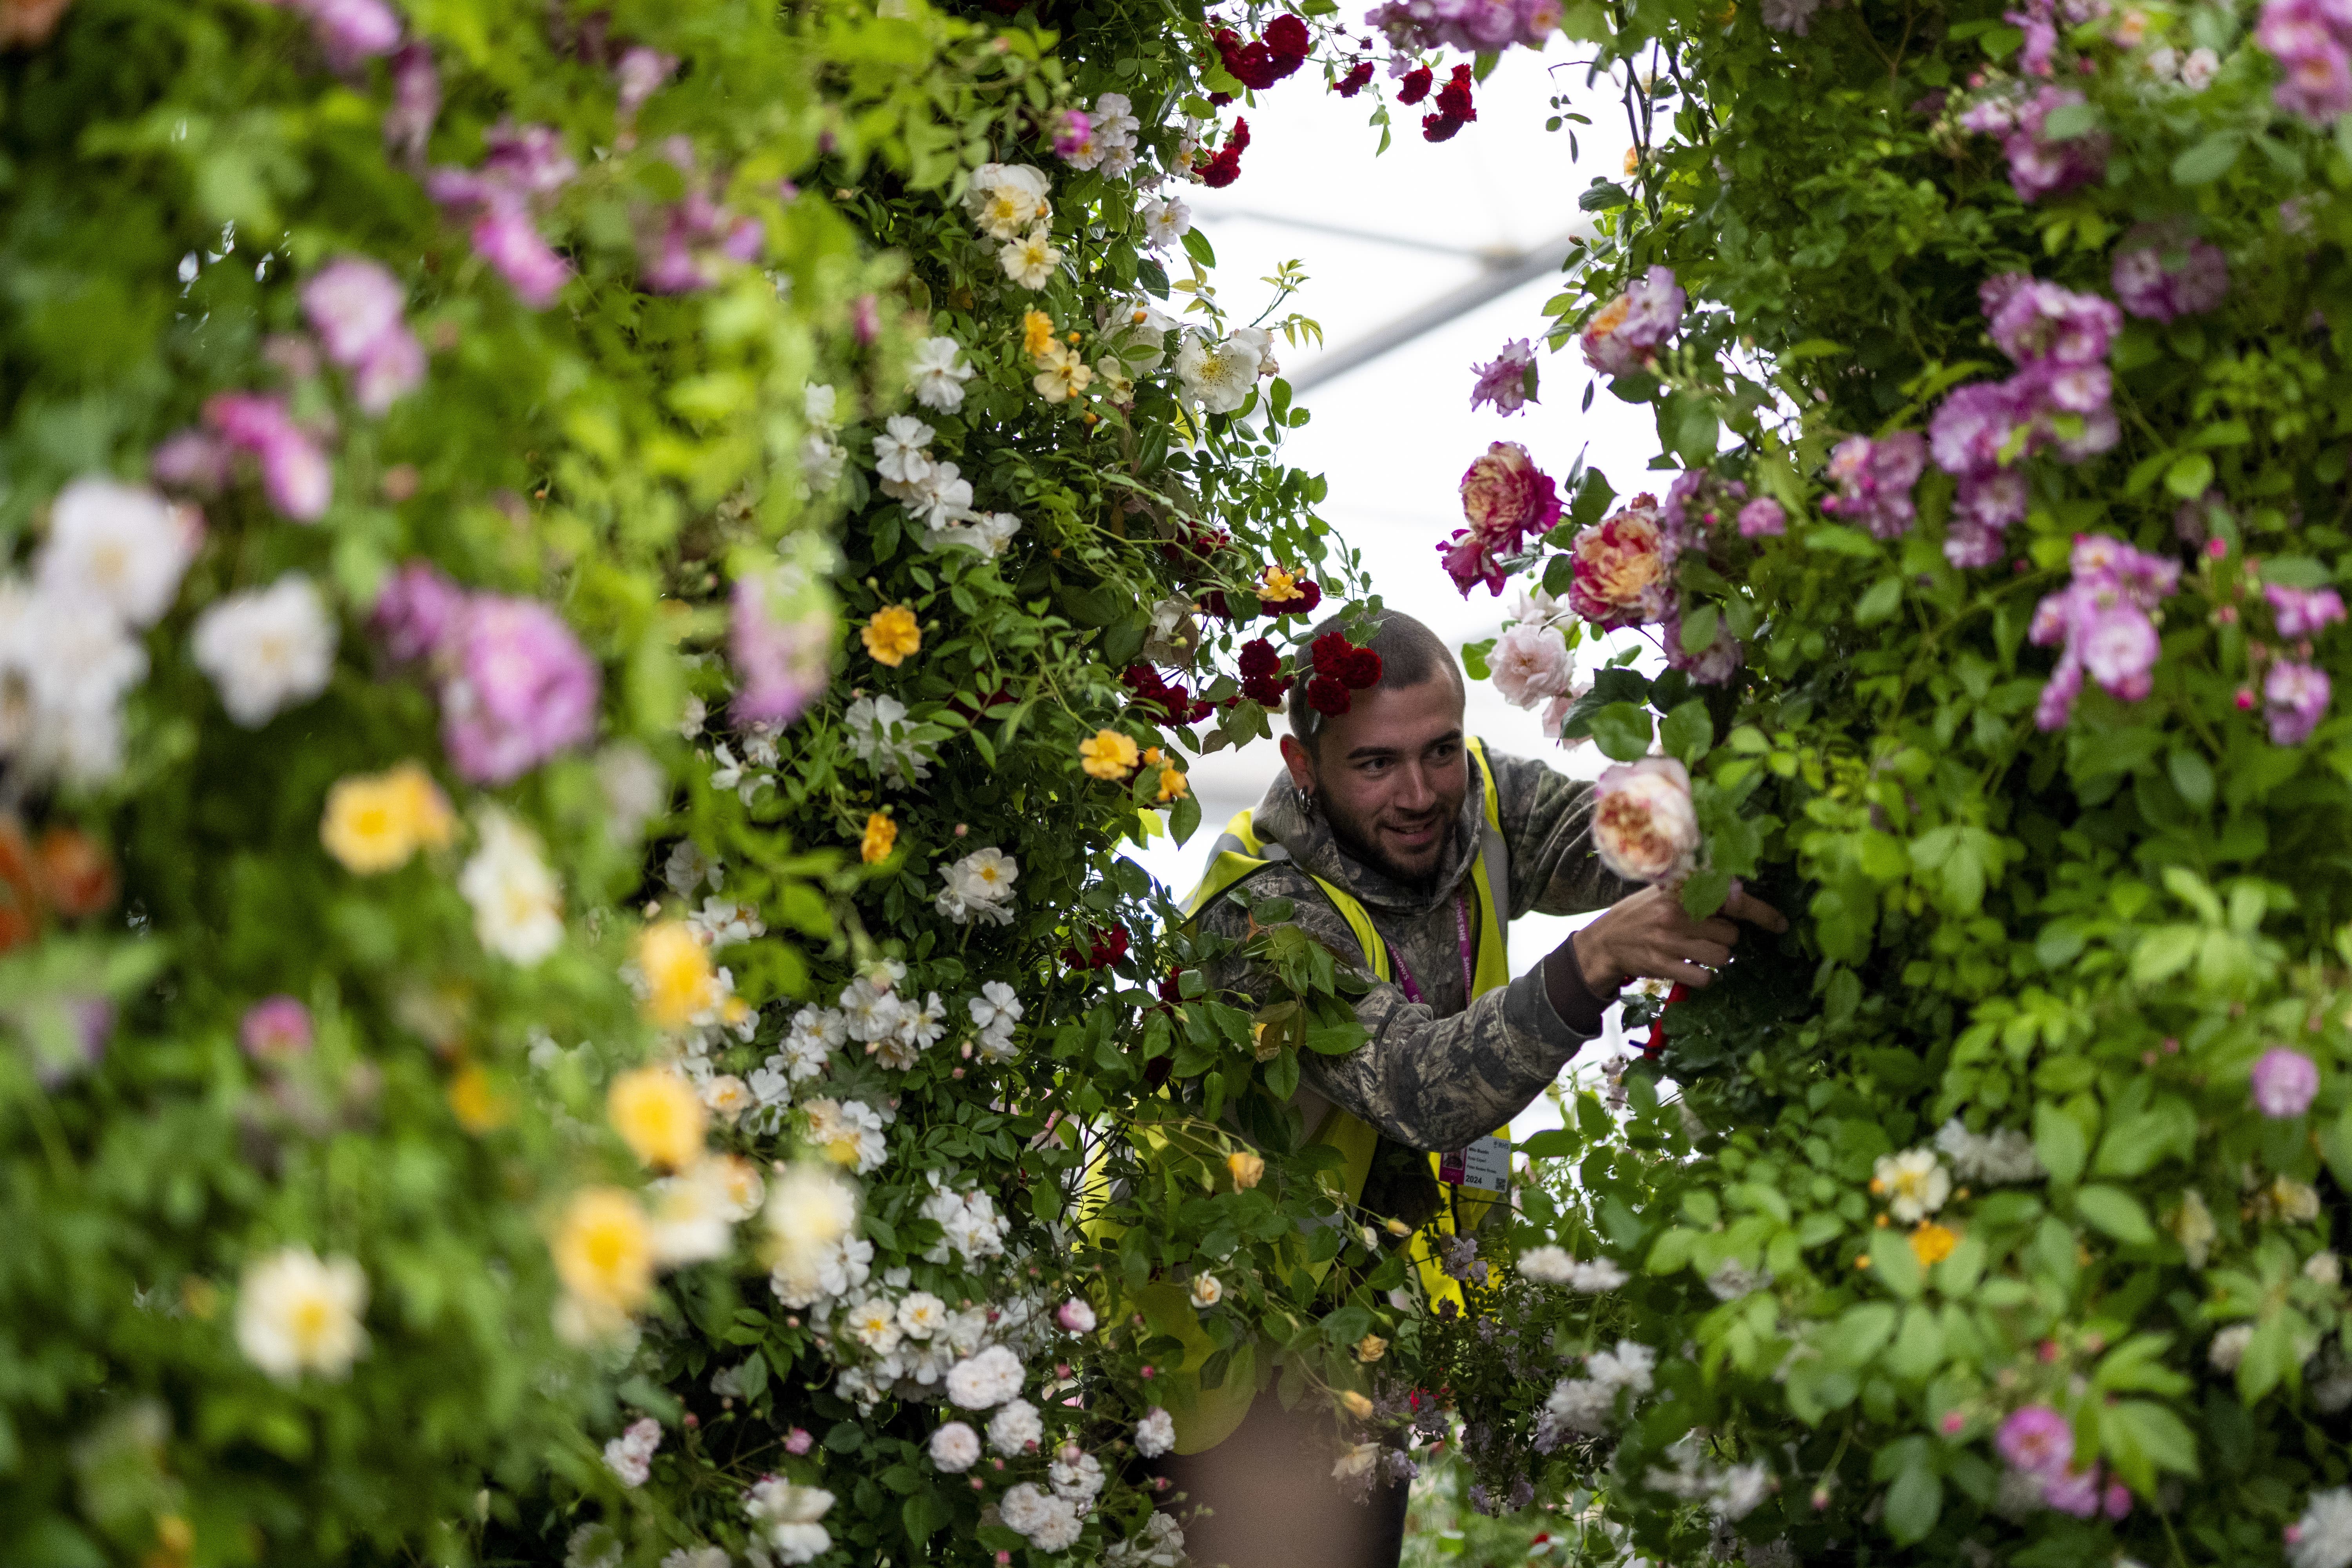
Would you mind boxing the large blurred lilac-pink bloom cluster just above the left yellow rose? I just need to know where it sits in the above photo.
[369,562,600,785]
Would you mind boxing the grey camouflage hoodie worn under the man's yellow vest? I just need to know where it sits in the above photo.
[1202,748,1635,1189]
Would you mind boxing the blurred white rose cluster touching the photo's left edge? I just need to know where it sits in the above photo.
[0,475,198,783]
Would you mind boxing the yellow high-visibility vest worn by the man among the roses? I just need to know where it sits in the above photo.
[1087,740,1510,1453]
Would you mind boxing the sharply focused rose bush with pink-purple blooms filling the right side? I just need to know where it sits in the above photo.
[1364,0,2352,1568]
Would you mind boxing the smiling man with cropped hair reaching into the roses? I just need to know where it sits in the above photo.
[1162,611,1788,1568]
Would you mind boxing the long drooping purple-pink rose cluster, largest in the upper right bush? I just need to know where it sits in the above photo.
[1929,273,2124,566]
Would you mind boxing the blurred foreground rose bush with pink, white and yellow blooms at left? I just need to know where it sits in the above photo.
[0,0,1082,1563]
